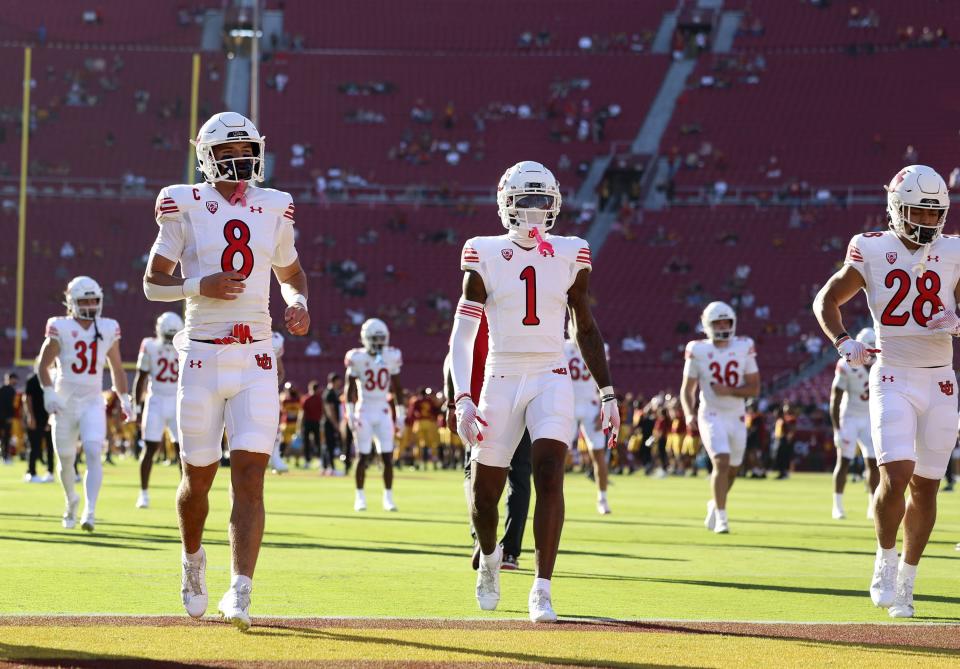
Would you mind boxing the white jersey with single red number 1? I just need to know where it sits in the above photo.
[460,234,591,374]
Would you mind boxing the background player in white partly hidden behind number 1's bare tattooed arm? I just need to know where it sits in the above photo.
[563,339,610,515]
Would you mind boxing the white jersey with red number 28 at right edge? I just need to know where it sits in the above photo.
[844,231,960,367]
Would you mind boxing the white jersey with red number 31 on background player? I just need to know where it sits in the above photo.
[46,316,120,396]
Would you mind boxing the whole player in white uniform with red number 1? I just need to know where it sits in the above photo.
[450,161,620,622]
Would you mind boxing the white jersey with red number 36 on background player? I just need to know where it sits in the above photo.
[683,337,759,414]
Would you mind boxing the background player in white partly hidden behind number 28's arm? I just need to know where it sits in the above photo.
[830,328,880,520]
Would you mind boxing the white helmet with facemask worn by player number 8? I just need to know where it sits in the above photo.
[190,112,266,183]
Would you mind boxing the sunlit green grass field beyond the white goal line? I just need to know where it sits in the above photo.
[0,461,960,666]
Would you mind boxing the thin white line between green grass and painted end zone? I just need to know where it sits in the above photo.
[0,612,960,628]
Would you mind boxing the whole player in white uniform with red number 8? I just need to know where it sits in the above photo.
[143,112,310,630]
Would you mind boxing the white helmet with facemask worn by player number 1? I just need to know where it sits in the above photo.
[497,160,562,239]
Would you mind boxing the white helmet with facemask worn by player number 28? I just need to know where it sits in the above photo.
[884,165,950,244]
